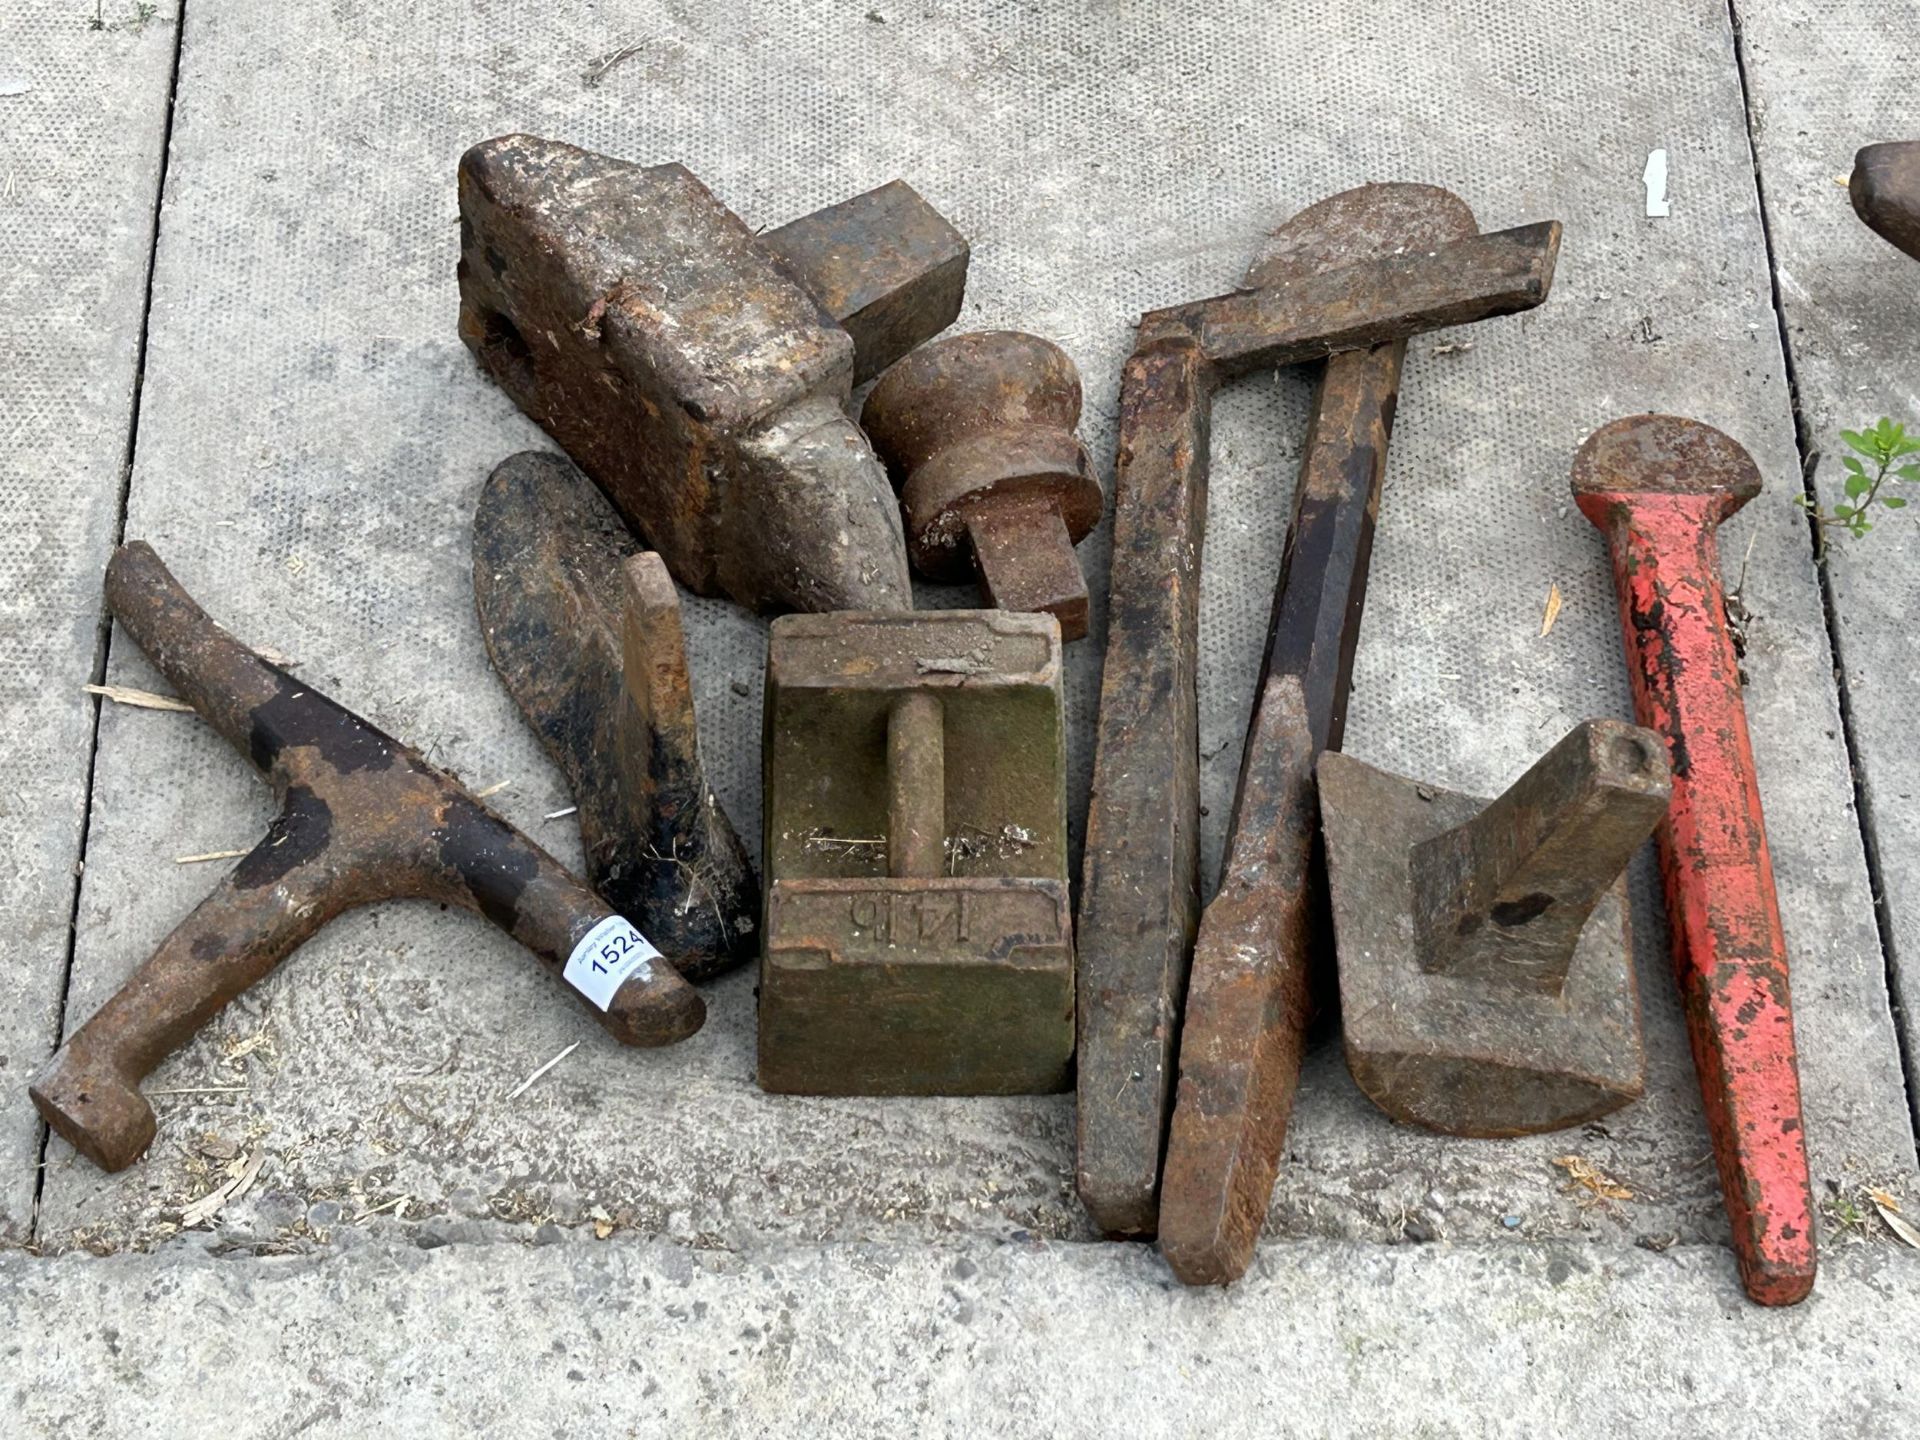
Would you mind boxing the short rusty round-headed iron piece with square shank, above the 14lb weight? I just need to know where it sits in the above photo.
[860,330,1106,639]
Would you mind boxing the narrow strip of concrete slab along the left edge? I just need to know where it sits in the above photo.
[0,0,175,1238]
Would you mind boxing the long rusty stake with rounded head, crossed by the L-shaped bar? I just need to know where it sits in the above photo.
[1160,184,1476,1284]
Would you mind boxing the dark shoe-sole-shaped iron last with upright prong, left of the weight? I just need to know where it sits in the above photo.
[474,451,760,981]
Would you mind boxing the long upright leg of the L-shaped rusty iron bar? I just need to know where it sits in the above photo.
[1073,340,1215,1236]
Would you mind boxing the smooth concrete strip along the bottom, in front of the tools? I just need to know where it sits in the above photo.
[0,1240,1920,1440]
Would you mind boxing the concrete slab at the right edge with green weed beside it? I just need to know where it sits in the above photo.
[1736,0,1920,1114]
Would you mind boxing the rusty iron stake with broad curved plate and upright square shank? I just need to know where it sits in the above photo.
[1319,720,1668,1137]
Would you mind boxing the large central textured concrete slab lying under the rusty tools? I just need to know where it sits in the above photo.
[40,0,1914,1282]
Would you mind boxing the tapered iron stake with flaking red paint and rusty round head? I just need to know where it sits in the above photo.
[1572,415,1814,1306]
